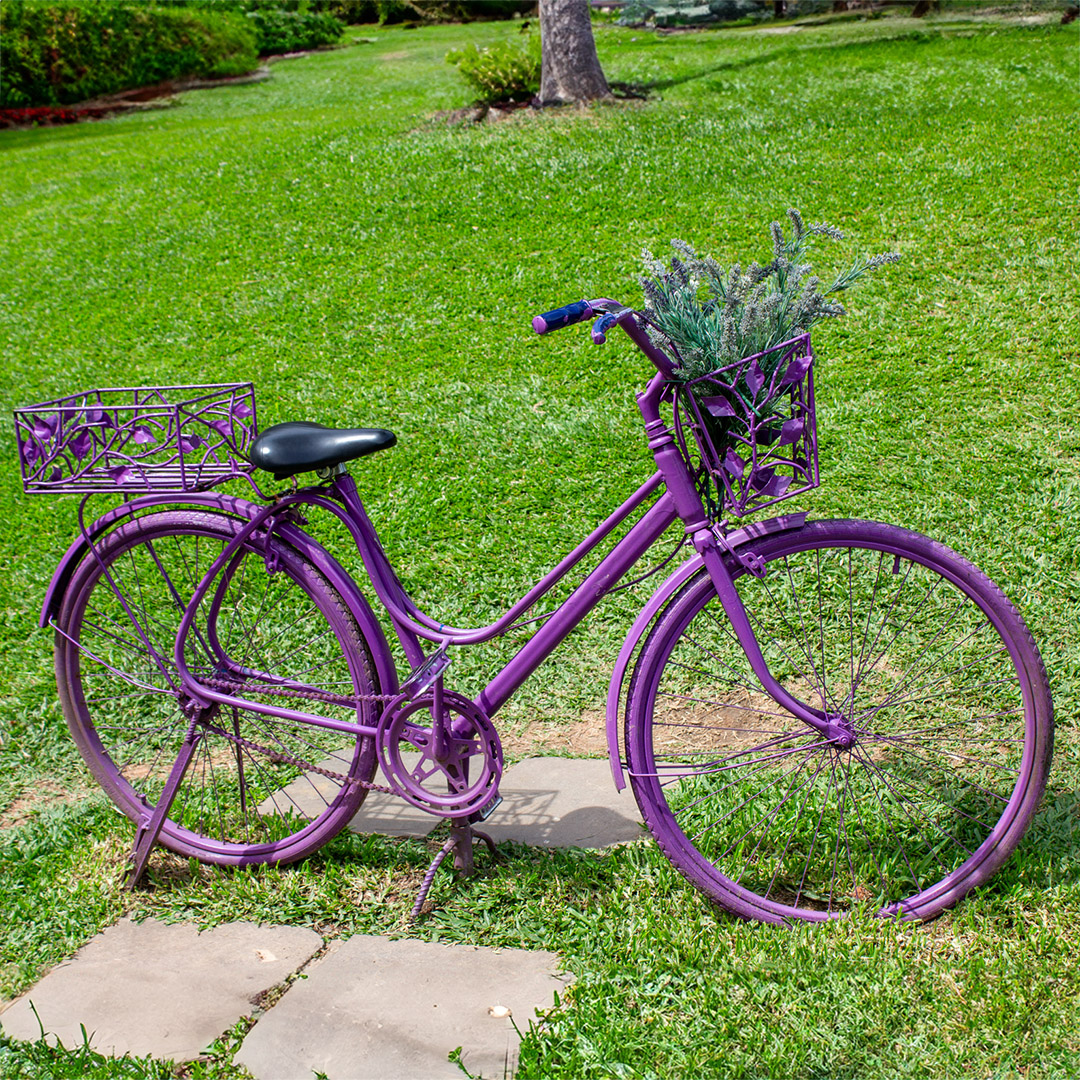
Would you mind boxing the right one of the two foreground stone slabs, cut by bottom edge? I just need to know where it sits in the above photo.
[234,936,567,1080]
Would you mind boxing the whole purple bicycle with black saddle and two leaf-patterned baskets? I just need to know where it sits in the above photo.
[15,299,1053,922]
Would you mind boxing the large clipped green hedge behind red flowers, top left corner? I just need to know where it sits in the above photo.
[0,0,256,107]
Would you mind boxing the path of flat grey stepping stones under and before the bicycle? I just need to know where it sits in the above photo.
[0,758,644,1080]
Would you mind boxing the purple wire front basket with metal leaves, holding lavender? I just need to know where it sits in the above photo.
[675,334,819,517]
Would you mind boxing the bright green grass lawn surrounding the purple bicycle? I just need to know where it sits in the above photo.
[0,8,1080,1078]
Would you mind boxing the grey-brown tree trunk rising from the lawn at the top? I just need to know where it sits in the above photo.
[538,0,611,105]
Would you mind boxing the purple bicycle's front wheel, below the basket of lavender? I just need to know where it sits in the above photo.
[625,521,1053,922]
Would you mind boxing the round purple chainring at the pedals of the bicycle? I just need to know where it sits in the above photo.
[375,691,502,818]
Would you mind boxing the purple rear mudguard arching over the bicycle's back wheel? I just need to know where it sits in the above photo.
[38,491,399,694]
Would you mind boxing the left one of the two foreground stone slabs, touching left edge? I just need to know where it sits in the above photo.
[0,919,323,1061]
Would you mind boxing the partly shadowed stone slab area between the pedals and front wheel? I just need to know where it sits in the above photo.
[477,757,645,848]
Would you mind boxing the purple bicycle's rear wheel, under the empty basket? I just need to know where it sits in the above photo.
[56,510,379,865]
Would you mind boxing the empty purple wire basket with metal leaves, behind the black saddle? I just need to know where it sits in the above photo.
[15,382,257,492]
